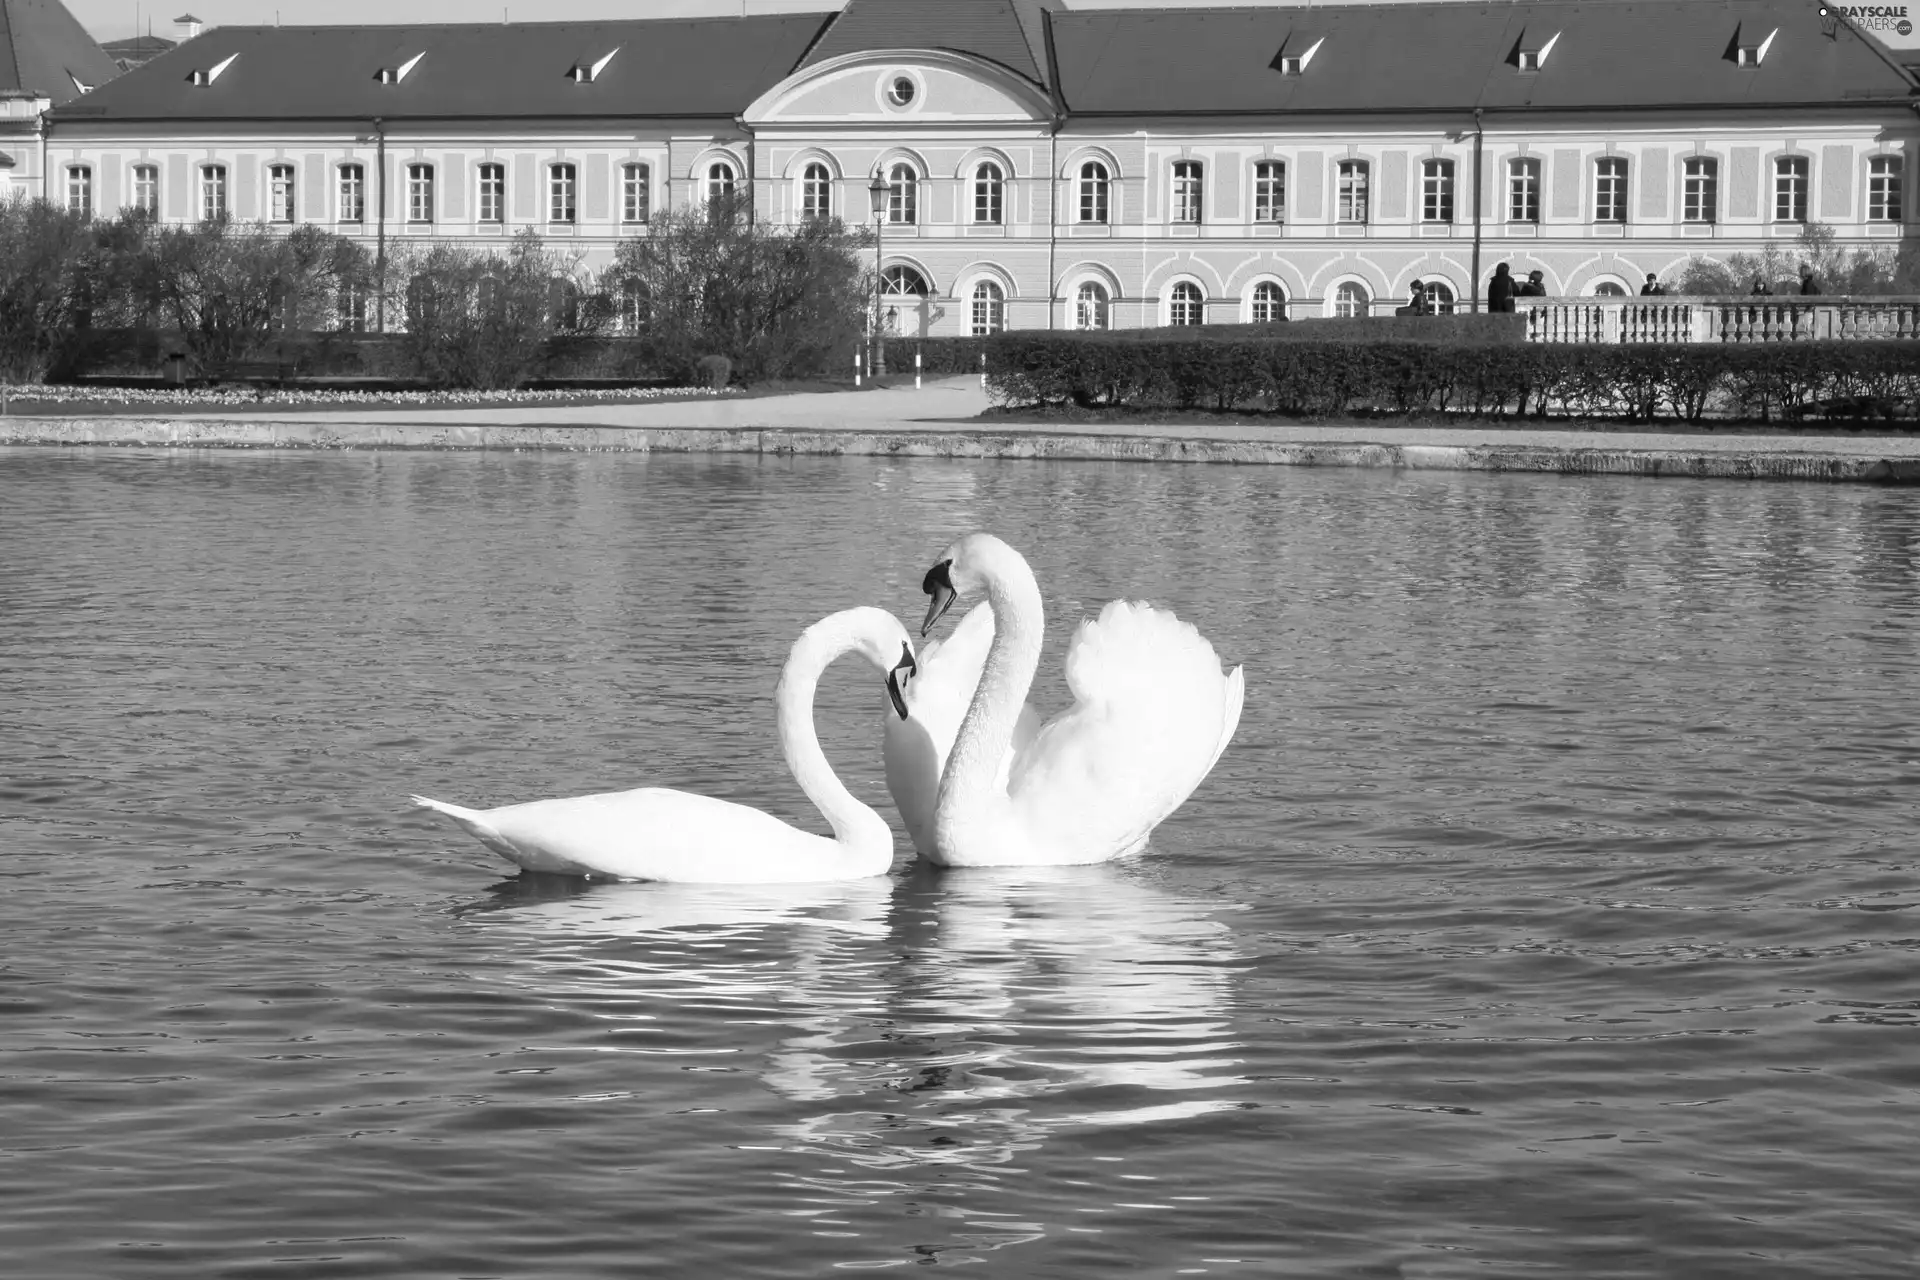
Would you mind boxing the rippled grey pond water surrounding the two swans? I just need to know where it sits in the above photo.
[0,449,1920,1280]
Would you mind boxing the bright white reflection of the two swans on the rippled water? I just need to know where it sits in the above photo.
[467,864,1244,1190]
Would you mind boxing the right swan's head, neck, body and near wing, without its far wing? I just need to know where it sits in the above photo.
[920,533,1246,867]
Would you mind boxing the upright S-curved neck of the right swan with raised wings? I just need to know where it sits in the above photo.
[935,545,1046,821]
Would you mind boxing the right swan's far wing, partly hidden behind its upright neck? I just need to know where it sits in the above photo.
[881,603,1041,858]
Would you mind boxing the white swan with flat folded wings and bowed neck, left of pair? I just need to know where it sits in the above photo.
[413,608,914,885]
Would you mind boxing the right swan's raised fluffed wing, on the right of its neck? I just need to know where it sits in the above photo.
[1008,601,1244,856]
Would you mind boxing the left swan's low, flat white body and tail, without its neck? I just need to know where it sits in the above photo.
[430,787,864,885]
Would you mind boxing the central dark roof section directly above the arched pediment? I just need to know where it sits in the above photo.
[801,0,1058,84]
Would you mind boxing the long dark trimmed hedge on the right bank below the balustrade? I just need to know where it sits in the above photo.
[987,333,1920,422]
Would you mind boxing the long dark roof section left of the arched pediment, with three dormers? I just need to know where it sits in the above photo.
[50,13,828,119]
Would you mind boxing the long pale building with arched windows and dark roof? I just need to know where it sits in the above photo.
[35,0,1920,334]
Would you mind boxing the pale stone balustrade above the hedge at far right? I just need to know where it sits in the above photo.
[1513,296,1920,342]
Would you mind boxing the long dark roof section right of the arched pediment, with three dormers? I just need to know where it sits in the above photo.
[1052,0,1910,115]
